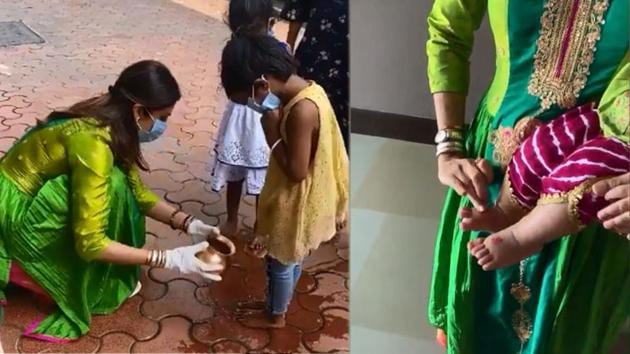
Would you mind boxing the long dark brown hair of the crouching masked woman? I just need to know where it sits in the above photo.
[47,60,181,171]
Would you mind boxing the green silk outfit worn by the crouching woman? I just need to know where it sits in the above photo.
[0,119,158,340]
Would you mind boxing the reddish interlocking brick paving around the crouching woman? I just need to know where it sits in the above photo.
[0,0,348,353]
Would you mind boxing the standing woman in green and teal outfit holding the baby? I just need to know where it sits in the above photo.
[427,0,630,354]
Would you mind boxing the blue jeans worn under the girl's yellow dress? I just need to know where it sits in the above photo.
[267,257,302,315]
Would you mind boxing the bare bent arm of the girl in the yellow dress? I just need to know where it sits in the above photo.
[263,100,319,183]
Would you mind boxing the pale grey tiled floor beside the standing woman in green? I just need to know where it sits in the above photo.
[350,134,630,354]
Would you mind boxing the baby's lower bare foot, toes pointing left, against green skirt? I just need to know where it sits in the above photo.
[469,228,543,270]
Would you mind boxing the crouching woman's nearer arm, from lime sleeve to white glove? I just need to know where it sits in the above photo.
[66,131,222,280]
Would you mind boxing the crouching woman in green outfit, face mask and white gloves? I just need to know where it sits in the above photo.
[0,61,233,342]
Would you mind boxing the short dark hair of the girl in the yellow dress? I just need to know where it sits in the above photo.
[221,35,297,97]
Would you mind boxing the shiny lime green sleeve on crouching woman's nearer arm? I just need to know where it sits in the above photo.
[67,131,114,261]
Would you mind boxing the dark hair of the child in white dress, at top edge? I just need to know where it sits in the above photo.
[227,0,274,35]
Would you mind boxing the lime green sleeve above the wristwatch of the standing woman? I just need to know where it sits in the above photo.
[427,0,488,94]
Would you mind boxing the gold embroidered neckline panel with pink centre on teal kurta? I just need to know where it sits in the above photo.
[528,0,608,109]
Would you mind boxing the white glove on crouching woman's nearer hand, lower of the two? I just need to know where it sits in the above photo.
[164,242,224,281]
